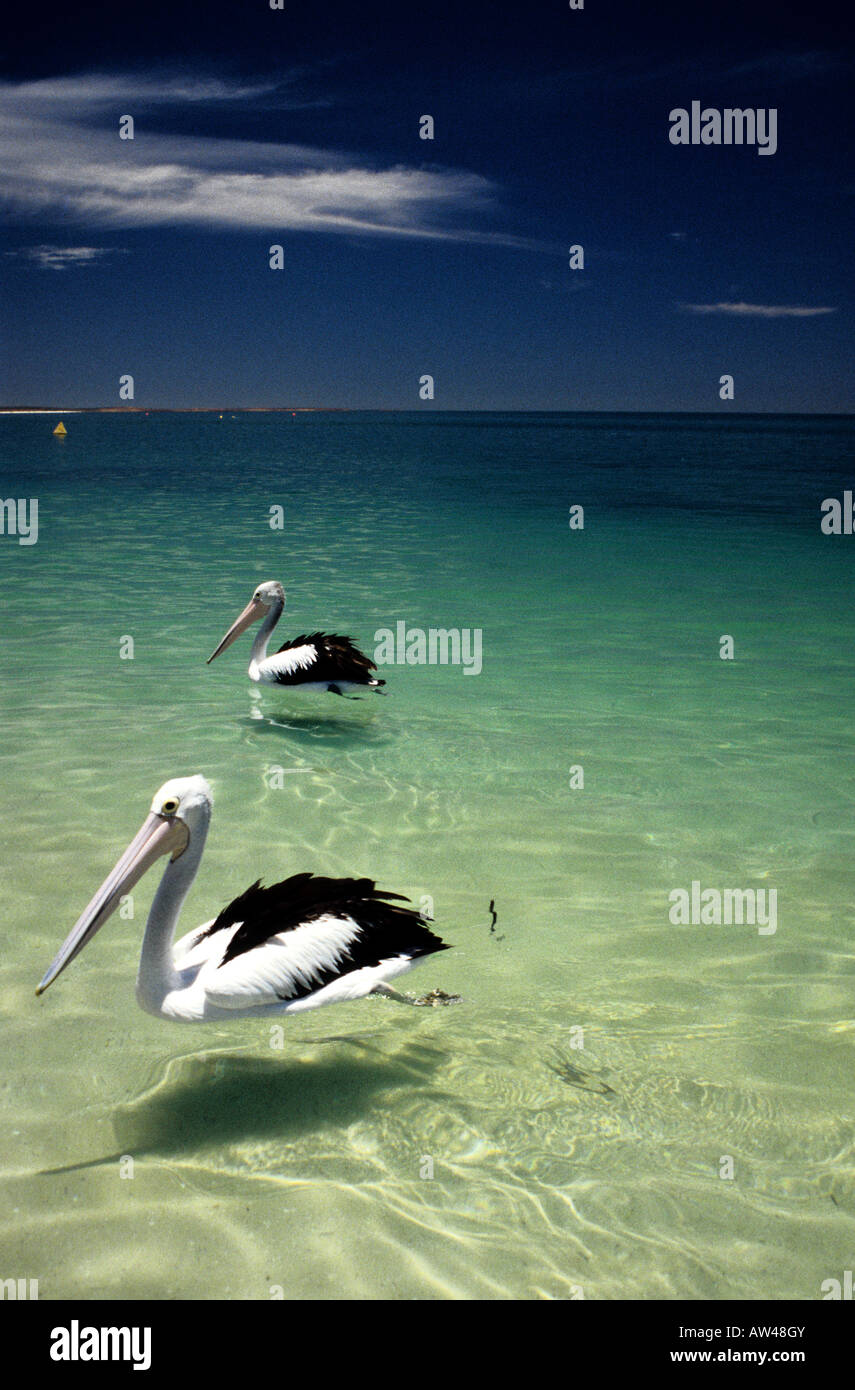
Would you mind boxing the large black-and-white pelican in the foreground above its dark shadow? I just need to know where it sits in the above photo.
[36,776,450,1023]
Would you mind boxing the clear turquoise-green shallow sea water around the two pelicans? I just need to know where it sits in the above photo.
[0,414,855,1298]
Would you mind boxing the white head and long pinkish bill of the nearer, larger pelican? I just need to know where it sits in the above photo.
[36,776,214,994]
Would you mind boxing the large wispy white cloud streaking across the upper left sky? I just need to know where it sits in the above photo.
[0,75,530,246]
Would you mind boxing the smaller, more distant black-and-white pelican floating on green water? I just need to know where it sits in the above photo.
[206,580,386,695]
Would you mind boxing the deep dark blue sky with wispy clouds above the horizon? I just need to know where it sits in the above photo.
[0,0,855,411]
